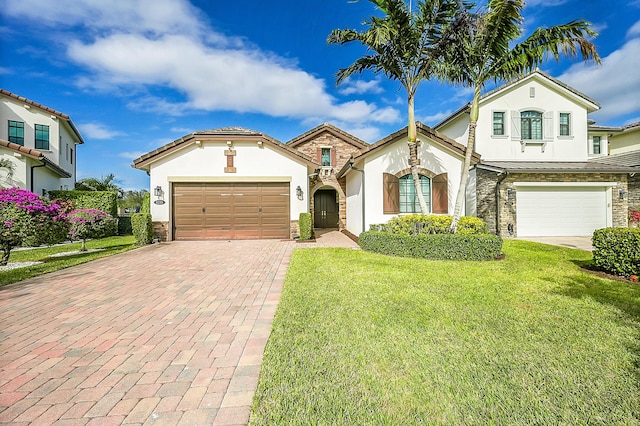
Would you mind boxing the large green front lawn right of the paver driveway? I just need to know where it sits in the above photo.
[251,241,640,425]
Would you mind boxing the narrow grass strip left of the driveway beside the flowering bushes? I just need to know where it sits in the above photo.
[0,235,135,286]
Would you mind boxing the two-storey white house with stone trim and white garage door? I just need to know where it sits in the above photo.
[435,70,638,237]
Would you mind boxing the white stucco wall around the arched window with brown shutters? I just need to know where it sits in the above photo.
[356,134,464,233]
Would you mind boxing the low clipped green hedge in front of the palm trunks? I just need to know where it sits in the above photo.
[359,231,502,260]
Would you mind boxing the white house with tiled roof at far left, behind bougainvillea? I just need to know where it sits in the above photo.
[0,89,84,194]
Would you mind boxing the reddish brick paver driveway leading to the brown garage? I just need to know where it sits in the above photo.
[0,240,294,425]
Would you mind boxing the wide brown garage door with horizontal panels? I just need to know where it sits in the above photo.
[173,182,290,240]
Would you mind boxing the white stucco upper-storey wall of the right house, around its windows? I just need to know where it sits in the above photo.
[438,75,606,161]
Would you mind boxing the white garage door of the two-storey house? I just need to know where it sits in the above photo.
[516,186,607,237]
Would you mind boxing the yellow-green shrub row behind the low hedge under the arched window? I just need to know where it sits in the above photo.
[371,214,488,235]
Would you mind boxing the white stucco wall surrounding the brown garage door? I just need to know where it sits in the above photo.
[150,141,309,228]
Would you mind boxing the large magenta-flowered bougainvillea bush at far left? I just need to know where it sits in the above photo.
[0,188,68,266]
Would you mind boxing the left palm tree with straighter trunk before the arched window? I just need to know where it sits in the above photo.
[327,0,469,213]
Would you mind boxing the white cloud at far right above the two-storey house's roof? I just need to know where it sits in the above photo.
[558,38,640,121]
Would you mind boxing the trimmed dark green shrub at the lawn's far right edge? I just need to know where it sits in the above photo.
[591,228,640,277]
